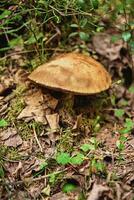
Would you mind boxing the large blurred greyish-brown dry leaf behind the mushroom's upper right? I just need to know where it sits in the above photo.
[92,33,123,61]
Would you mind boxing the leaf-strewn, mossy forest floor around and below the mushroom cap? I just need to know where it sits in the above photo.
[0,32,134,200]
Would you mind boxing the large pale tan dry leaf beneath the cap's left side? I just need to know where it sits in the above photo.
[18,90,47,124]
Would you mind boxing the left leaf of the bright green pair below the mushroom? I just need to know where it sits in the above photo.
[56,153,70,165]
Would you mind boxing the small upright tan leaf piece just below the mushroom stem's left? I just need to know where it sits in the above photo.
[46,113,59,131]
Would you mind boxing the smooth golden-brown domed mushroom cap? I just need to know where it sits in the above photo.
[29,53,111,95]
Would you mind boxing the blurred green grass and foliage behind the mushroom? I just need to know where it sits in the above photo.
[0,0,134,66]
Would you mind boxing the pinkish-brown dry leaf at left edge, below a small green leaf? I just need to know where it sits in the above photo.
[0,128,22,147]
